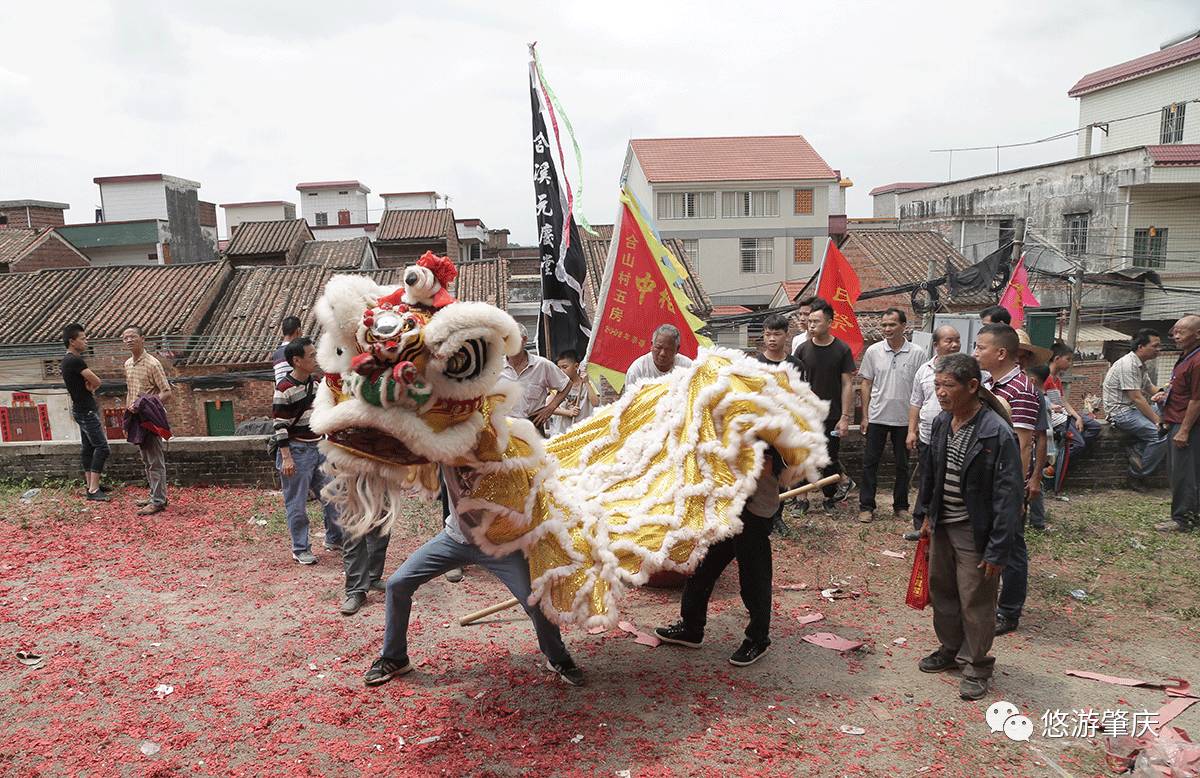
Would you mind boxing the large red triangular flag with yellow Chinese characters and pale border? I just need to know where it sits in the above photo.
[588,195,708,390]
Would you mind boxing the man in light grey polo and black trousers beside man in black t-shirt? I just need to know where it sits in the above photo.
[858,309,925,522]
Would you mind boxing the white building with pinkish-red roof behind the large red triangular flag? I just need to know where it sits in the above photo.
[625,136,850,306]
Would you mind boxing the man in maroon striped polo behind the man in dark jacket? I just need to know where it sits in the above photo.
[974,324,1042,635]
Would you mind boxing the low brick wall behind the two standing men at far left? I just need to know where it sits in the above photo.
[0,436,278,489]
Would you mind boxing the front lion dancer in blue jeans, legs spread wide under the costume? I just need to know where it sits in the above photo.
[362,466,583,686]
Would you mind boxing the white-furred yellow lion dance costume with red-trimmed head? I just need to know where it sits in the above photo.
[312,253,828,627]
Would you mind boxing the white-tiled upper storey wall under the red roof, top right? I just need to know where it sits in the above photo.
[1078,61,1200,156]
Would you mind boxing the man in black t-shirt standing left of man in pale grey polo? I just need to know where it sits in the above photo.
[794,298,854,510]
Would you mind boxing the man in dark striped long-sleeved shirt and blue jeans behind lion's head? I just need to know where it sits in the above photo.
[271,337,345,564]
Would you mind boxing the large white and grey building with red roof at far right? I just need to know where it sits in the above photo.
[872,34,1200,322]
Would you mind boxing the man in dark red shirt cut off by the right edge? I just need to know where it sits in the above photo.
[1157,316,1200,532]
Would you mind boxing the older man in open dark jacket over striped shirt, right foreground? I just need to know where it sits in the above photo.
[917,354,1025,700]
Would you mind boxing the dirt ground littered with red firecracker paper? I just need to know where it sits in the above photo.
[0,487,1200,776]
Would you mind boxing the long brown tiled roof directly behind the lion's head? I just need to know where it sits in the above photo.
[186,258,508,365]
